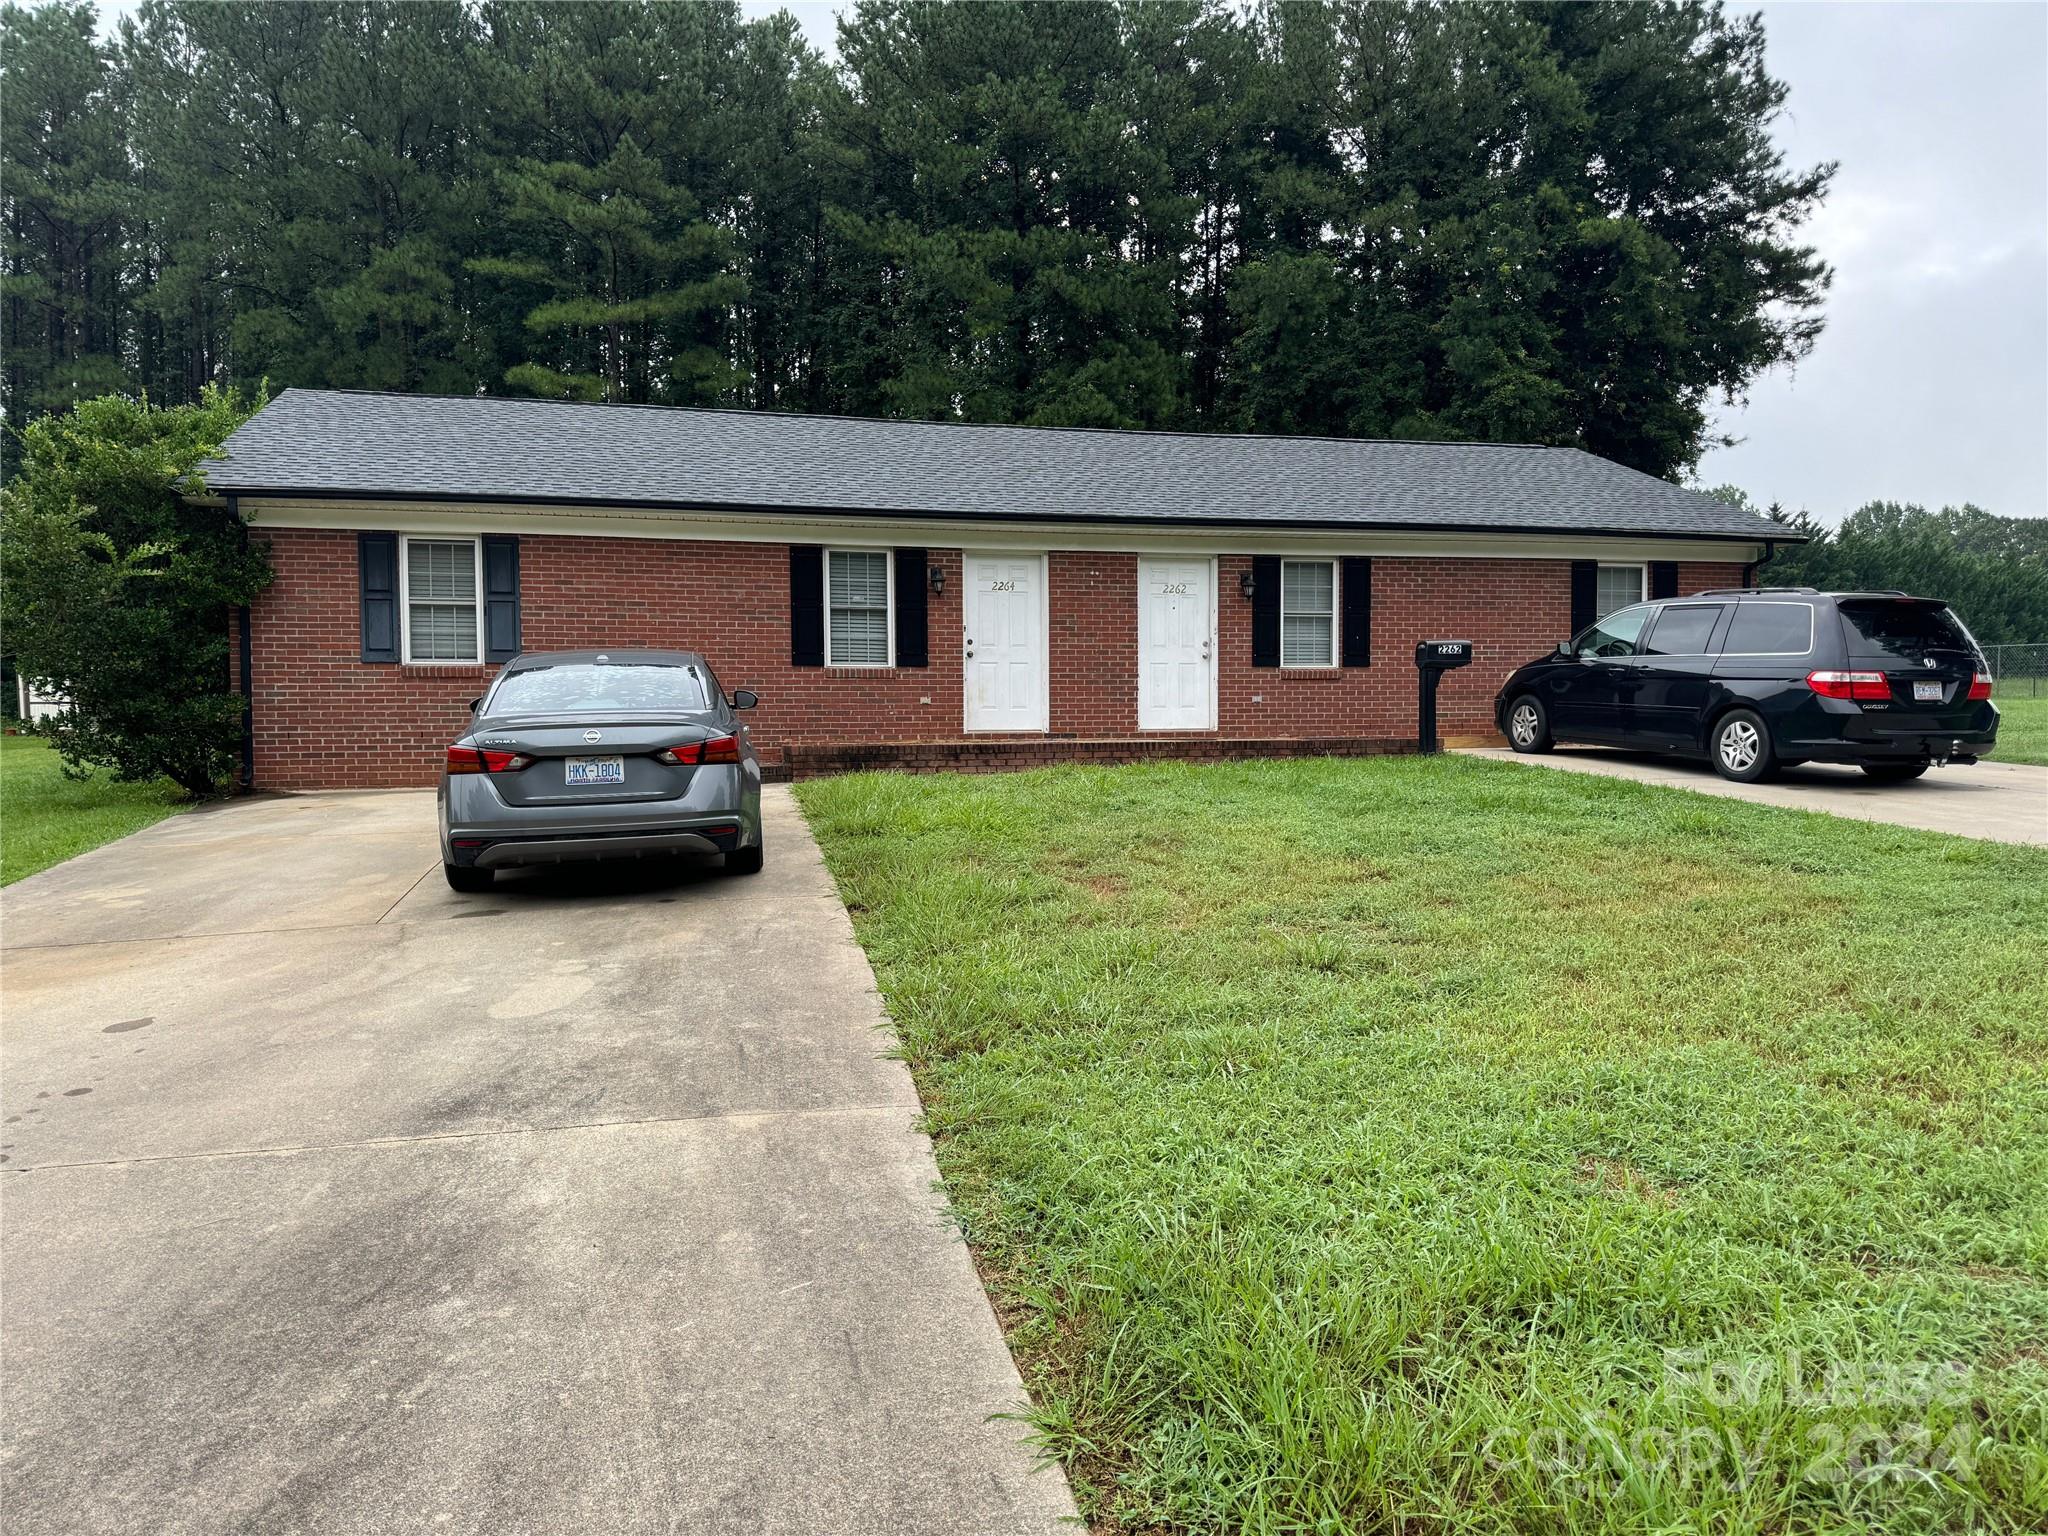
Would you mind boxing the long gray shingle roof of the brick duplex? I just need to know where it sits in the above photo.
[207,389,1796,541]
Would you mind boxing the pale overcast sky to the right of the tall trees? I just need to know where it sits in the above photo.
[1700,0,2048,520]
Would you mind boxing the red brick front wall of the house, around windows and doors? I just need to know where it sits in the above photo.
[239,528,1743,788]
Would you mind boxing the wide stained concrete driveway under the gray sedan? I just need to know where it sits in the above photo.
[0,788,1073,1536]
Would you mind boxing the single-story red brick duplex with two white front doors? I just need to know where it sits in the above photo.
[207,389,1784,788]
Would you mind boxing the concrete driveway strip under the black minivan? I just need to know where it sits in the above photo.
[1466,748,2048,844]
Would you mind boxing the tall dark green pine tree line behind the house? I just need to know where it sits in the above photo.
[0,0,1833,475]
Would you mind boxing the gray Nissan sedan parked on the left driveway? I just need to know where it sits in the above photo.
[438,651,762,891]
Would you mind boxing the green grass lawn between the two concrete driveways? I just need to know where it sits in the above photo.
[799,758,2048,1536]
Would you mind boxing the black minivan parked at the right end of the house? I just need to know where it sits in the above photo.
[1493,588,1999,782]
